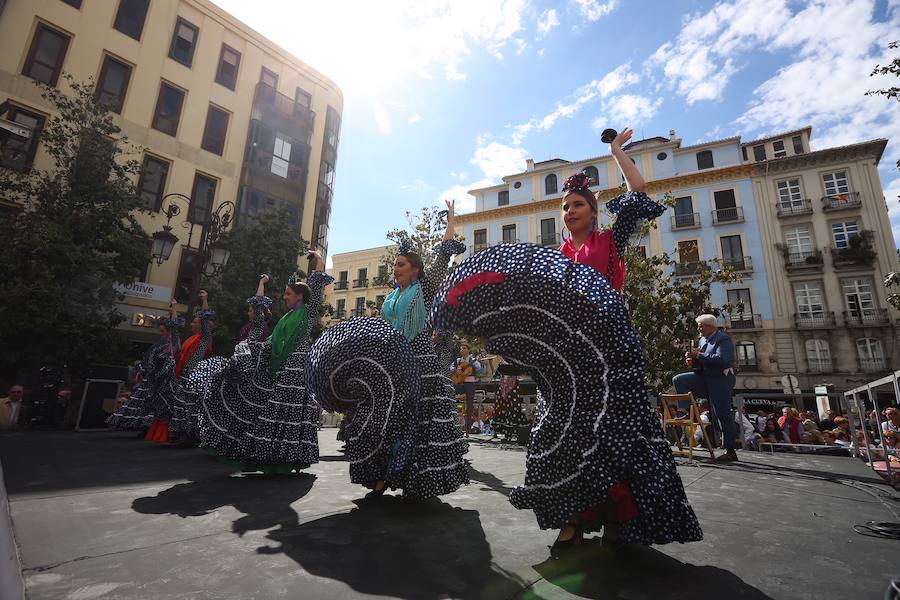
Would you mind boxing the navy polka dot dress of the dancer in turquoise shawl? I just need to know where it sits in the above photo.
[309,240,469,499]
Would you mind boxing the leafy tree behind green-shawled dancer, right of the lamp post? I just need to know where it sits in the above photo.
[203,212,309,355]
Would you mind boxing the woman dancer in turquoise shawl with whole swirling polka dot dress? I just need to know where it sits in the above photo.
[307,202,469,499]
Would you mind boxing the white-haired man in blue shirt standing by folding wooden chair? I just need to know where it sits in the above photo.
[672,315,738,462]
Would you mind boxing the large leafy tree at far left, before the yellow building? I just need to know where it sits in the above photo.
[0,74,150,374]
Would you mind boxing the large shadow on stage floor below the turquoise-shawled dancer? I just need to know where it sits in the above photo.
[257,496,528,600]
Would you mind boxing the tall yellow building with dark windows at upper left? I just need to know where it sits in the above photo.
[0,0,343,341]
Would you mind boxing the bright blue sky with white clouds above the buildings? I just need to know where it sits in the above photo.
[213,0,900,262]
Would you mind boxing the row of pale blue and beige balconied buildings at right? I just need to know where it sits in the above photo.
[458,127,900,392]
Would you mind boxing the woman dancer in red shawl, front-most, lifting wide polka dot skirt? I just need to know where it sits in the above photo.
[432,129,702,556]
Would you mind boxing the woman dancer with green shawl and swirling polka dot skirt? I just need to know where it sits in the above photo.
[200,253,333,475]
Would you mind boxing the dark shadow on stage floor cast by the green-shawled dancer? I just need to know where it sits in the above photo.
[131,473,316,535]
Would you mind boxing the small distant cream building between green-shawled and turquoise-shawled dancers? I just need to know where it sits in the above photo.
[325,246,393,322]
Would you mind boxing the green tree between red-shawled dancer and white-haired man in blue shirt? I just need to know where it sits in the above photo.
[623,194,743,395]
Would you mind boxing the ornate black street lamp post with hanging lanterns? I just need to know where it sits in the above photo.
[150,192,235,315]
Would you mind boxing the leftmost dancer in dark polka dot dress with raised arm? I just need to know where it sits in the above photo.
[106,300,184,437]
